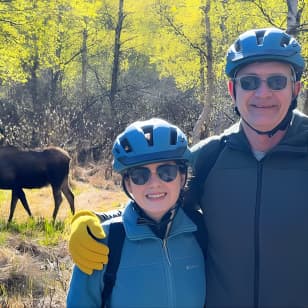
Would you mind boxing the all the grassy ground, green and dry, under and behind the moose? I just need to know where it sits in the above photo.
[0,172,127,308]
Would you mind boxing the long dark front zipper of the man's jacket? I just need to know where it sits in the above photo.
[254,160,263,308]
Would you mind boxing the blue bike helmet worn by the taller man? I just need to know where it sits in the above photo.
[226,28,305,80]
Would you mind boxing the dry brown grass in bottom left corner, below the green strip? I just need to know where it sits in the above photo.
[0,236,72,307]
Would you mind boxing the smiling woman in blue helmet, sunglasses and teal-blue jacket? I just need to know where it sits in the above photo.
[67,119,205,308]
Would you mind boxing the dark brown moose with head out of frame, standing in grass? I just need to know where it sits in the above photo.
[0,146,75,222]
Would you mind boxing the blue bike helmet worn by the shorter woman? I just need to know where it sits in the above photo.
[112,118,191,173]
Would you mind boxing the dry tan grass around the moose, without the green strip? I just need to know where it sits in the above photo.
[0,167,127,308]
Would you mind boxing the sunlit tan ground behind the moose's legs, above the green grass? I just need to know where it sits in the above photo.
[0,166,128,222]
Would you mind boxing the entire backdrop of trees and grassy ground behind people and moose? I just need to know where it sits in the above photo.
[0,0,308,308]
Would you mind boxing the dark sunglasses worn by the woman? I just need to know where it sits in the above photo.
[127,164,179,185]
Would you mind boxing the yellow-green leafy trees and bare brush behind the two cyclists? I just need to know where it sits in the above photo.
[0,0,308,164]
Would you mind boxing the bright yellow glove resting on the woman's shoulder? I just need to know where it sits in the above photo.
[68,211,109,275]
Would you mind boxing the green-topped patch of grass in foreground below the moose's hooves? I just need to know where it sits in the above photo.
[0,218,72,307]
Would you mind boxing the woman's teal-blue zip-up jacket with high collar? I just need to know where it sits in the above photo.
[67,203,205,308]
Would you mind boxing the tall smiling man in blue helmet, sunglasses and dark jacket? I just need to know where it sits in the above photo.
[70,28,308,308]
